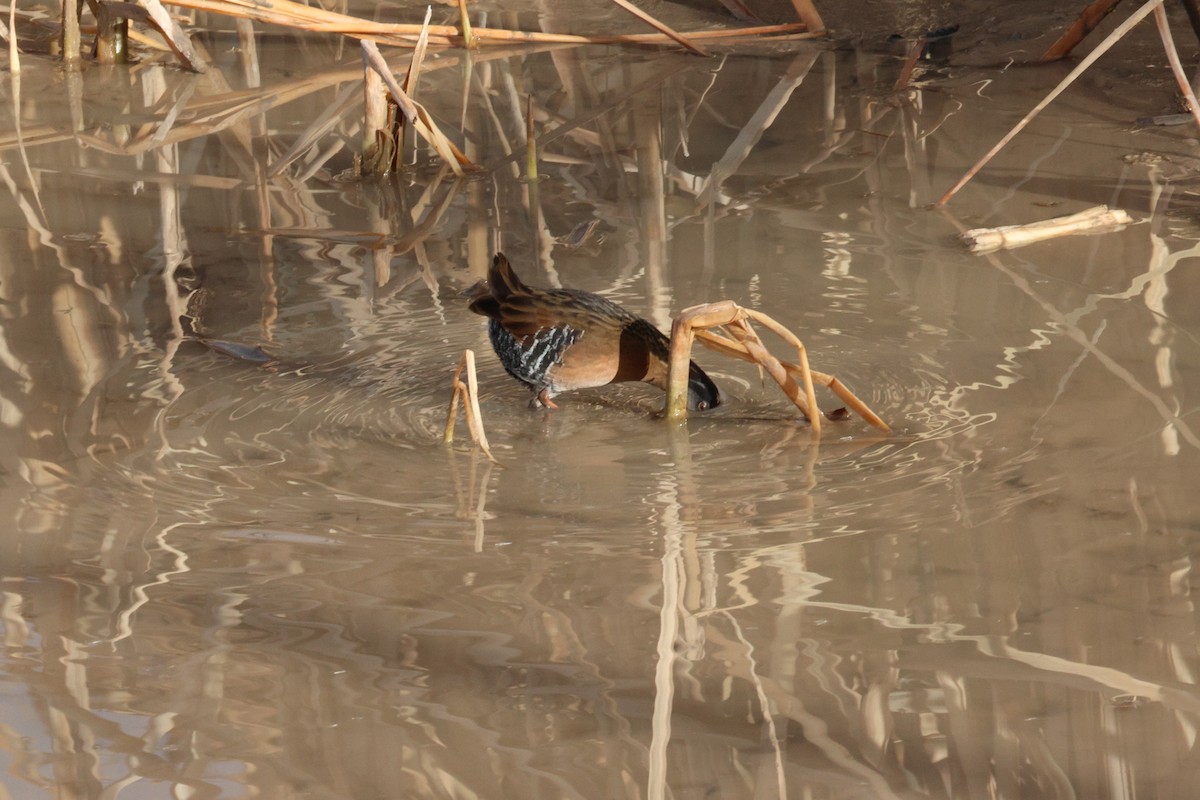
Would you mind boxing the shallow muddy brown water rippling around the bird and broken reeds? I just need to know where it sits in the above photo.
[0,7,1200,799]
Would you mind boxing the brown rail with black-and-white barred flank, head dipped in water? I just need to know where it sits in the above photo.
[463,253,721,411]
